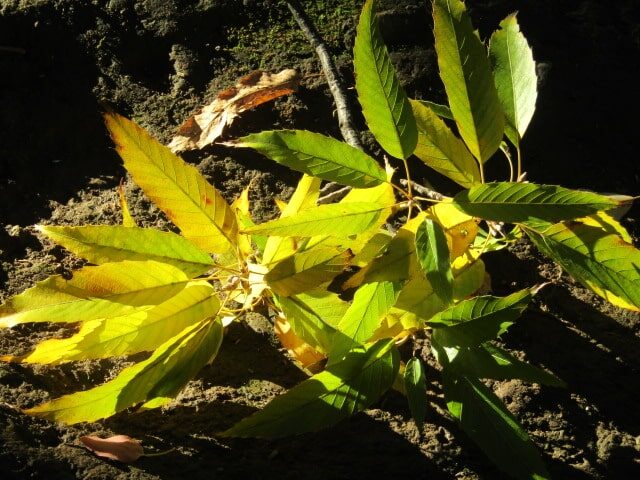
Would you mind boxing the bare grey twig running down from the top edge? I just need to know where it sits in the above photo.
[287,0,363,150]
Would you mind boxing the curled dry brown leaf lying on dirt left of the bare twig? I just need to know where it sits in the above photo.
[169,69,300,152]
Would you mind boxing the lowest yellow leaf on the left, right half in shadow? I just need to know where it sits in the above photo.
[25,319,223,424]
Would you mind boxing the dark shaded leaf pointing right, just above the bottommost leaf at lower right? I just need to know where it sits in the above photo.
[451,343,567,387]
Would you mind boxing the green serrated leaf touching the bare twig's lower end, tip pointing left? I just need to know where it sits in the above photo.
[233,130,387,188]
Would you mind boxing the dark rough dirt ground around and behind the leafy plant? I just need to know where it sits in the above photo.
[0,0,640,480]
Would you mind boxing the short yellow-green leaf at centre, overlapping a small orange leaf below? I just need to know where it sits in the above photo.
[275,290,349,354]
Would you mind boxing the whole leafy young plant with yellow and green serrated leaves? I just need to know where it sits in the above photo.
[0,0,640,478]
